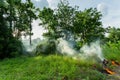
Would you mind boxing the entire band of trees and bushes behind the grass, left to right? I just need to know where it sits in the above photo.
[0,0,120,58]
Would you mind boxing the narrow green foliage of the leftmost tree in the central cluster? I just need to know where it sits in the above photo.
[39,8,61,40]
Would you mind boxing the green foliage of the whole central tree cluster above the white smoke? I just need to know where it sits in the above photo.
[39,0,105,48]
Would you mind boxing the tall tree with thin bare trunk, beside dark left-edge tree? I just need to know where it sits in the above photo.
[14,0,37,44]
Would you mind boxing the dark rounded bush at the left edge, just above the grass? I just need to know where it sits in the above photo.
[0,37,22,59]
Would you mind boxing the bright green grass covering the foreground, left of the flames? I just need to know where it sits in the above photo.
[0,55,106,80]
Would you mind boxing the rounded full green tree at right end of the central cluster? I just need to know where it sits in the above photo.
[73,8,105,44]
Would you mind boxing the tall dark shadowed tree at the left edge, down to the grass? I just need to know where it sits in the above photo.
[0,1,22,59]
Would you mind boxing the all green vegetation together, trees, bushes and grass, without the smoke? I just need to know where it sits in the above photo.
[0,0,120,80]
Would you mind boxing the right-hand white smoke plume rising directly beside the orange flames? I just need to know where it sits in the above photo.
[80,41,104,61]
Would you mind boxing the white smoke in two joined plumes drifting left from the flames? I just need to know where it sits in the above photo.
[57,38,104,61]
